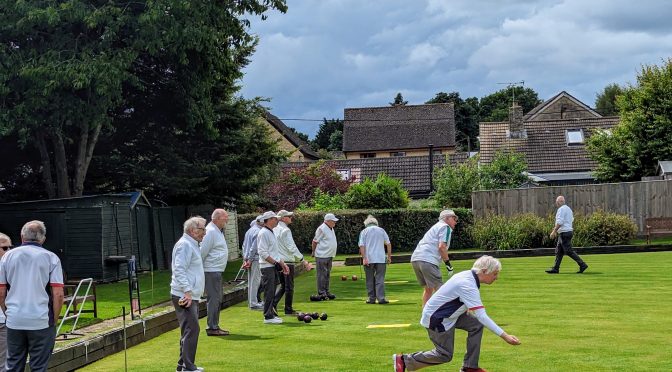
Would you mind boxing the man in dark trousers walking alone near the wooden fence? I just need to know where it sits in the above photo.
[546,195,588,274]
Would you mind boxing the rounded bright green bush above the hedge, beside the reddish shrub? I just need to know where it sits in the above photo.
[345,173,409,209]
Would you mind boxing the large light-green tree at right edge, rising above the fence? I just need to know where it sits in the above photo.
[587,59,672,181]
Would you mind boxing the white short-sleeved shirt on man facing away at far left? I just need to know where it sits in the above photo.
[0,242,63,331]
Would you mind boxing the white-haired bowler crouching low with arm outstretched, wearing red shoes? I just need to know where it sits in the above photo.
[392,256,520,372]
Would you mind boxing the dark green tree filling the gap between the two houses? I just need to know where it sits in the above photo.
[425,92,479,151]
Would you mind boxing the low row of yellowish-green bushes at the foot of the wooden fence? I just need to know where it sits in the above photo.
[470,211,637,250]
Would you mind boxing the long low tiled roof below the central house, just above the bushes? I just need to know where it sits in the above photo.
[283,152,467,196]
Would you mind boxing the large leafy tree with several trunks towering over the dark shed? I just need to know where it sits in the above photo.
[0,0,287,201]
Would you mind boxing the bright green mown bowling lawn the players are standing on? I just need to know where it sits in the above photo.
[83,252,672,371]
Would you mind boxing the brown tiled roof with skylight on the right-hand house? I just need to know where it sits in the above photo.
[479,117,619,173]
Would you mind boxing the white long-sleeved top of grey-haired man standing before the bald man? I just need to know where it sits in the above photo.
[170,233,205,302]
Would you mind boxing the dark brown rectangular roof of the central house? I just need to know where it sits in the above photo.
[343,103,455,152]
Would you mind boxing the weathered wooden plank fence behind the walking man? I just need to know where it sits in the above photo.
[471,180,672,234]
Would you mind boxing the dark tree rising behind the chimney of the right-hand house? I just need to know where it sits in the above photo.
[479,86,543,122]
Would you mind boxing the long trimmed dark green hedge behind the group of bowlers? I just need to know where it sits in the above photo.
[238,208,473,254]
